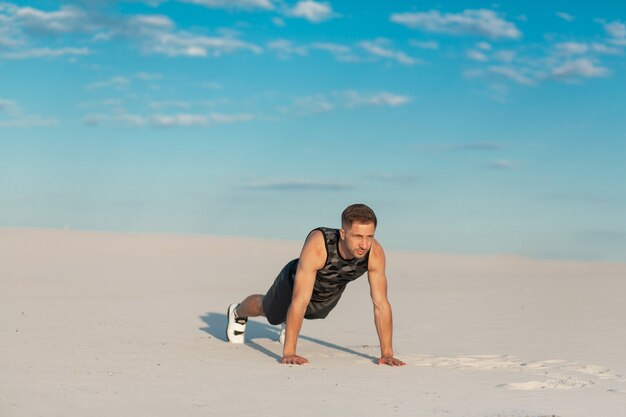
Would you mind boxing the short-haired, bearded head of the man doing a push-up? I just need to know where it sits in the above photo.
[339,204,378,258]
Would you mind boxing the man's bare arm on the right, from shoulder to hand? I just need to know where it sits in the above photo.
[367,241,406,366]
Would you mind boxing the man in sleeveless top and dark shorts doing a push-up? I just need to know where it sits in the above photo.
[226,204,405,366]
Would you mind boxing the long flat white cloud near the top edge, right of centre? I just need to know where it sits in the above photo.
[390,9,522,39]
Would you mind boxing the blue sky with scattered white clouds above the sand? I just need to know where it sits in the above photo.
[0,0,626,262]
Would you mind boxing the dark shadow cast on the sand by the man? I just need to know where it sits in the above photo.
[200,313,378,363]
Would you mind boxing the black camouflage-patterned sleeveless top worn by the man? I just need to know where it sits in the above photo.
[305,227,370,318]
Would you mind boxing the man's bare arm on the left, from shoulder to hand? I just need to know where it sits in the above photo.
[280,230,326,365]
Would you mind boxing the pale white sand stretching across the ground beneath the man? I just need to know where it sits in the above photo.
[0,229,626,417]
